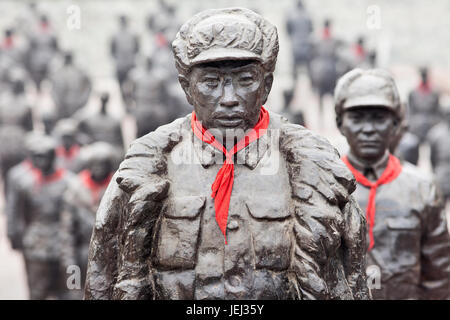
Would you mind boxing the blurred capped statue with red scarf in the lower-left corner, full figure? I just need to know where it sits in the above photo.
[7,136,74,300]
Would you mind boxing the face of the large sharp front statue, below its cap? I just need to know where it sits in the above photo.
[180,60,273,135]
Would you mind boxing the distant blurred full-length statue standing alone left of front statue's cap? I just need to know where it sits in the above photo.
[110,16,139,105]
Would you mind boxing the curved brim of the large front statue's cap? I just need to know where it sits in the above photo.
[191,48,262,65]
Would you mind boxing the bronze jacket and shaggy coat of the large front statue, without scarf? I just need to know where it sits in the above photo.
[85,113,368,299]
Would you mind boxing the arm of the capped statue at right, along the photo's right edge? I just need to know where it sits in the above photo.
[420,185,450,300]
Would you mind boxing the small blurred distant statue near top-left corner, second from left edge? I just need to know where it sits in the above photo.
[26,15,59,92]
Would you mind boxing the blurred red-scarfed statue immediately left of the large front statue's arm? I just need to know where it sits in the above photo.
[61,142,117,299]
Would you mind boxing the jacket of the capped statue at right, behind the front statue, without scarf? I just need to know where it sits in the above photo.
[355,163,450,300]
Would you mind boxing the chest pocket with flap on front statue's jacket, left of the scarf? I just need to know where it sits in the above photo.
[156,196,206,269]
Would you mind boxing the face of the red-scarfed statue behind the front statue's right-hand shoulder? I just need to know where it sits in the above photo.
[339,106,398,162]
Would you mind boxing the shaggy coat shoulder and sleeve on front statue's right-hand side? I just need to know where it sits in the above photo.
[281,125,369,299]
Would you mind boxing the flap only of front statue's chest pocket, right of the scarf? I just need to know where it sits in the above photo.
[245,196,290,219]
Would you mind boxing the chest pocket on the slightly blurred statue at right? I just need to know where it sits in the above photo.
[386,216,421,265]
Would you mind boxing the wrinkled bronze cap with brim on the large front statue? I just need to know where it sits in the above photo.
[172,8,278,74]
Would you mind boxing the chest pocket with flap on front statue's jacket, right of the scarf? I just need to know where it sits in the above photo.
[246,196,291,270]
